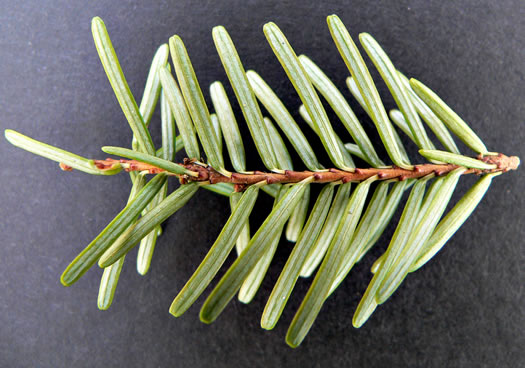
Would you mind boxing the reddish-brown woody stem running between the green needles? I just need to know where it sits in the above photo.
[82,153,520,192]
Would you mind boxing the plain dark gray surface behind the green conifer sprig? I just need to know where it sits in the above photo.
[0,0,525,367]
